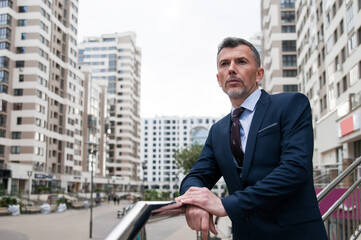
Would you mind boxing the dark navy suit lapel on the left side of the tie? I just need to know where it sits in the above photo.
[219,114,241,194]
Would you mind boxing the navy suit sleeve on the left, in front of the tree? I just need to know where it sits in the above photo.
[180,126,221,195]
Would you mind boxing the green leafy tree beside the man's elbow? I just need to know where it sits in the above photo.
[173,143,203,174]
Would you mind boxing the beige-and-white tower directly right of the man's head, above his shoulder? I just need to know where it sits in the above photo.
[261,0,298,93]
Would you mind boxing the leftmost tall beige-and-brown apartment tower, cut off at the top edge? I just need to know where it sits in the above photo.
[0,0,88,194]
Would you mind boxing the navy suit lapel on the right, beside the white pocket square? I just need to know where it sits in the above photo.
[241,90,270,187]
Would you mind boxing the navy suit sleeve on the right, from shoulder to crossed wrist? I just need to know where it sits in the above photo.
[222,94,313,220]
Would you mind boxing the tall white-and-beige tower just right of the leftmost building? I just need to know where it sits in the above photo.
[79,32,141,181]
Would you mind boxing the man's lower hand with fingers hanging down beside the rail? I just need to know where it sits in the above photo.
[185,205,218,240]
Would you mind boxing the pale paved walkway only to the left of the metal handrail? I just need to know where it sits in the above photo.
[0,201,128,240]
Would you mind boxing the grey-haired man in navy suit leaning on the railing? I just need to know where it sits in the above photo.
[176,38,327,240]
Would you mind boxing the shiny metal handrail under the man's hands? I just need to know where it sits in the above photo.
[106,201,202,240]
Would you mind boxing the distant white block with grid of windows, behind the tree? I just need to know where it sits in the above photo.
[141,117,225,196]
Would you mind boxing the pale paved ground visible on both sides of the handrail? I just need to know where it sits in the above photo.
[0,201,196,240]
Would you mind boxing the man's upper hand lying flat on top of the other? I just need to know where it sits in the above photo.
[175,187,227,217]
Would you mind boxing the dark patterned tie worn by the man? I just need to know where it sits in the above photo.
[231,107,244,167]
